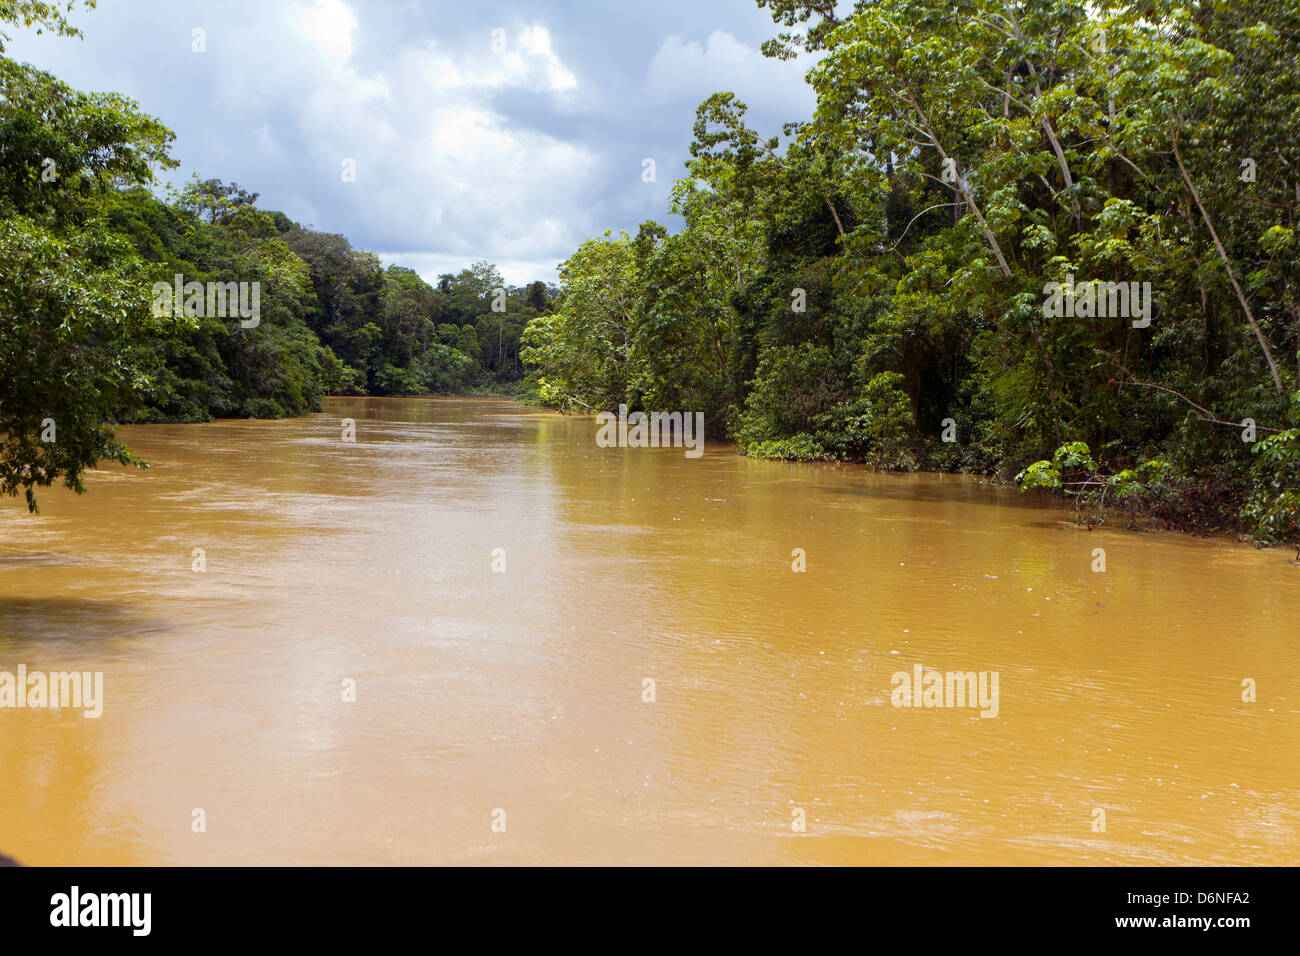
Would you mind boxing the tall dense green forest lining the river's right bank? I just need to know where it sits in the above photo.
[524,0,1300,540]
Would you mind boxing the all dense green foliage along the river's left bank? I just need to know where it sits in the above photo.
[0,0,553,510]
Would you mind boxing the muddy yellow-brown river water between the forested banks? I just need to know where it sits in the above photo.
[0,398,1300,865]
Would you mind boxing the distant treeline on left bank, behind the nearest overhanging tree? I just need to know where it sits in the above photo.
[109,179,554,421]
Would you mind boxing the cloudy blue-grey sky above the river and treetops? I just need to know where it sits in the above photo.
[5,0,814,285]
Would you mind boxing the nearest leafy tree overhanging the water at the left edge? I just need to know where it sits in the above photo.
[0,0,174,511]
